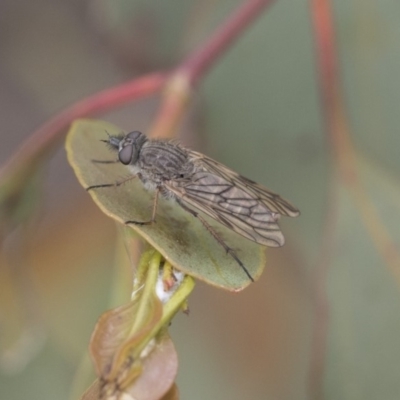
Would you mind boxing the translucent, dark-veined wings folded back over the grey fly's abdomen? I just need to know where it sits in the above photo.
[166,152,297,247]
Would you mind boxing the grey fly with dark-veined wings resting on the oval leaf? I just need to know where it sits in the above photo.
[86,131,299,281]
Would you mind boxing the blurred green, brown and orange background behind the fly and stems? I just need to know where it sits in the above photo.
[0,0,400,400]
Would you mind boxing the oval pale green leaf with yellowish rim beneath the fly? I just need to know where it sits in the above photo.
[66,120,265,291]
